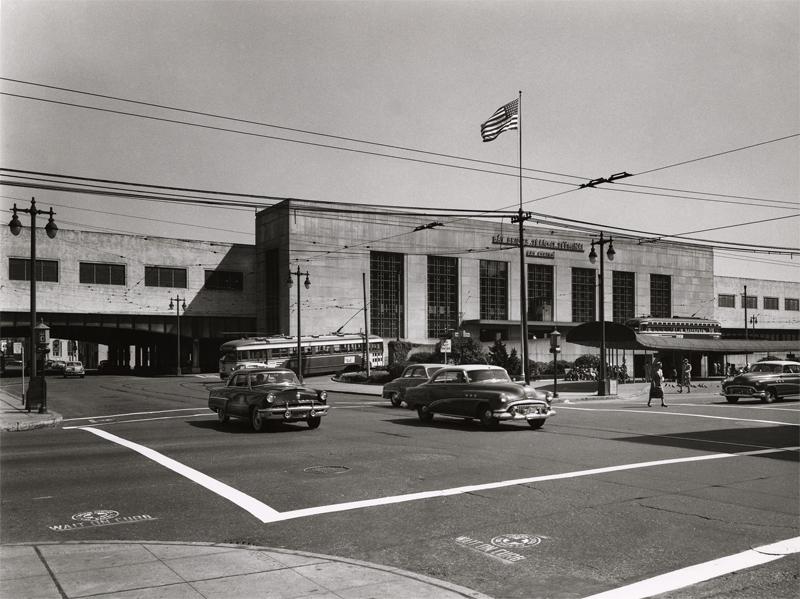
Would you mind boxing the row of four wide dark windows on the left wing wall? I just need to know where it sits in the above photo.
[8,258,244,291]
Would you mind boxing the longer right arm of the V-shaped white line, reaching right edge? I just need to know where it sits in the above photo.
[266,446,800,521]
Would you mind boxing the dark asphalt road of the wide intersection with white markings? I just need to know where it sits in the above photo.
[0,376,800,599]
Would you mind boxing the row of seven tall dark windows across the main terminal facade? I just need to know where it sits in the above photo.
[370,252,672,338]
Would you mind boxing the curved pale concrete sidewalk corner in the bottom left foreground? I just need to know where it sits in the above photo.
[0,541,490,599]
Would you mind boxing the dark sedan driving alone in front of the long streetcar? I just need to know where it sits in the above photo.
[208,368,328,432]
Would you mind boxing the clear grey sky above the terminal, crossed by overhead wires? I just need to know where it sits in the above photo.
[0,0,800,281]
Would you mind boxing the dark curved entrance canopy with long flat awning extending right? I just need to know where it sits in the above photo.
[567,322,800,354]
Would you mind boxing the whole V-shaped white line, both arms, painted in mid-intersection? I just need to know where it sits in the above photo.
[73,426,800,524]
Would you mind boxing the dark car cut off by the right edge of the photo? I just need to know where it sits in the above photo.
[720,360,800,403]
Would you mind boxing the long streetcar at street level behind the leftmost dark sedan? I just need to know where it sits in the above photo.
[219,333,384,380]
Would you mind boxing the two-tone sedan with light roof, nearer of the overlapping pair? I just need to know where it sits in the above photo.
[405,364,555,429]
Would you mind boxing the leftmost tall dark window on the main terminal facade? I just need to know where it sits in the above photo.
[369,252,403,338]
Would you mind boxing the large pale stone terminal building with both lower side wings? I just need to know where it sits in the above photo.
[0,200,800,374]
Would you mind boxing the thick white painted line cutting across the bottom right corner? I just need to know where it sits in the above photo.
[585,537,800,599]
